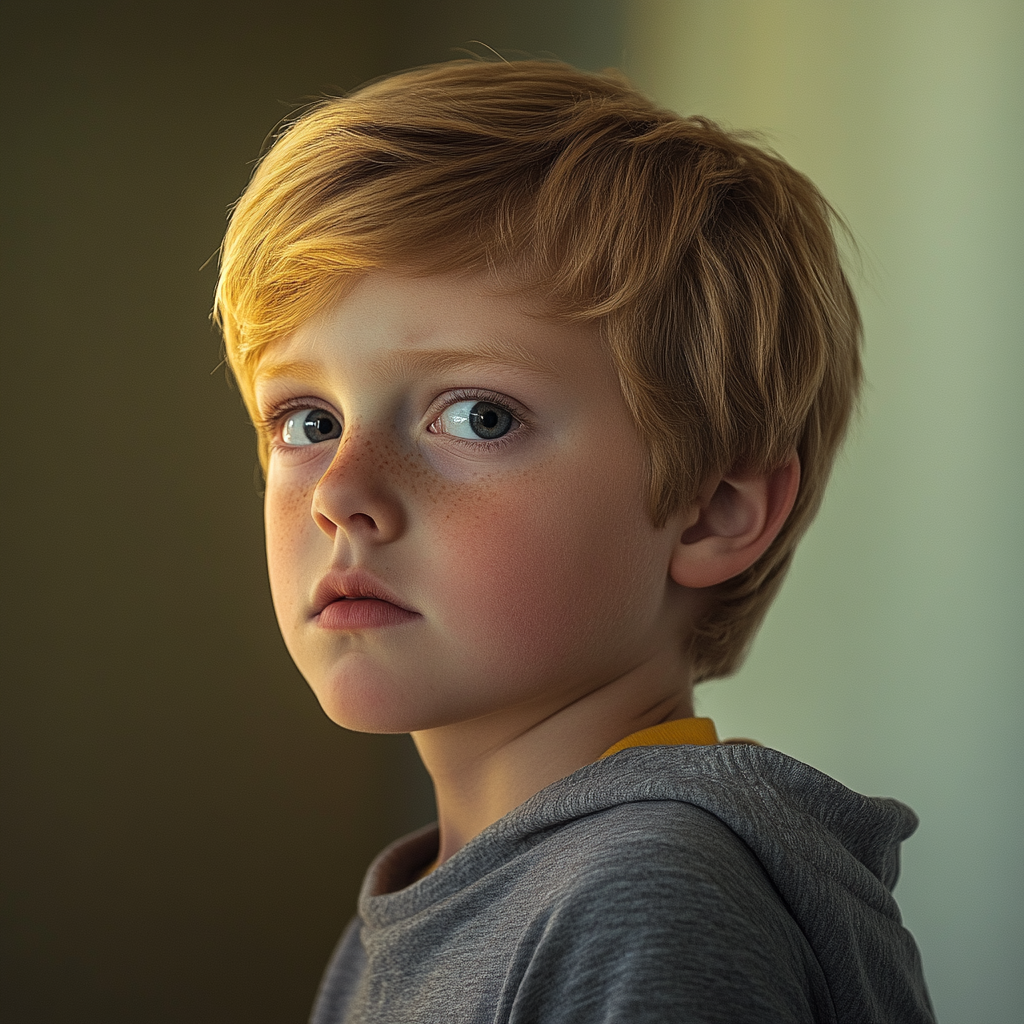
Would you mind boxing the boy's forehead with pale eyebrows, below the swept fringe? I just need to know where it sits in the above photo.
[254,270,605,392]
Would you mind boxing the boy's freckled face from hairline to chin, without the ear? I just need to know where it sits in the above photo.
[256,271,685,732]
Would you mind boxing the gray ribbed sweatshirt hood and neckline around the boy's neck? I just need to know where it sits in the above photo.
[359,743,918,924]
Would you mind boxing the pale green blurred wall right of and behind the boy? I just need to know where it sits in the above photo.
[625,0,1024,1024]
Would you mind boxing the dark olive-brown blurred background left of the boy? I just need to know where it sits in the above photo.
[0,0,623,1024]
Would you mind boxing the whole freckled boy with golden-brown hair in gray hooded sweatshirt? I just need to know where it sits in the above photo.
[217,61,932,1024]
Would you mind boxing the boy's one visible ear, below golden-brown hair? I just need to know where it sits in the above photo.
[669,452,800,588]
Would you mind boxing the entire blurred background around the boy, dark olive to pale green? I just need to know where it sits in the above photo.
[0,0,1024,1024]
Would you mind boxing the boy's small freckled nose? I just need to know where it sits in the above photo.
[310,425,404,544]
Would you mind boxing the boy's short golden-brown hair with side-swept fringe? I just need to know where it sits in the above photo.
[215,60,861,681]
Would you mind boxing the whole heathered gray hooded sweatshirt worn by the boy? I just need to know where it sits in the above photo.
[312,745,934,1024]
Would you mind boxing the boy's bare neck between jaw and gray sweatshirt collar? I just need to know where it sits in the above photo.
[413,647,693,863]
